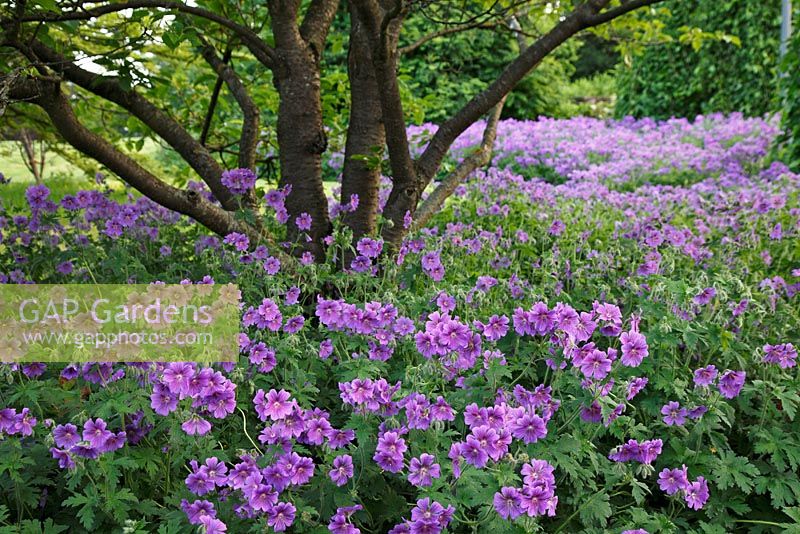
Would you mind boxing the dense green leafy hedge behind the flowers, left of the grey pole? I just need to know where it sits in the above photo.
[617,0,780,118]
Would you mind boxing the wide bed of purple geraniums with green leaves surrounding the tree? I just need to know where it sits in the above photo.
[0,115,800,533]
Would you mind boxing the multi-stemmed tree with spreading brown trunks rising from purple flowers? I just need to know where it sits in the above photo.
[0,0,658,260]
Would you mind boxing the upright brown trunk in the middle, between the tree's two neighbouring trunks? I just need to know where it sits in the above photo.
[341,4,386,239]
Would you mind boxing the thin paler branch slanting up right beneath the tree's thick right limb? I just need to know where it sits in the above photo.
[411,97,506,231]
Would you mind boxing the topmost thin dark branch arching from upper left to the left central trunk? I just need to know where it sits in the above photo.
[15,0,276,68]
